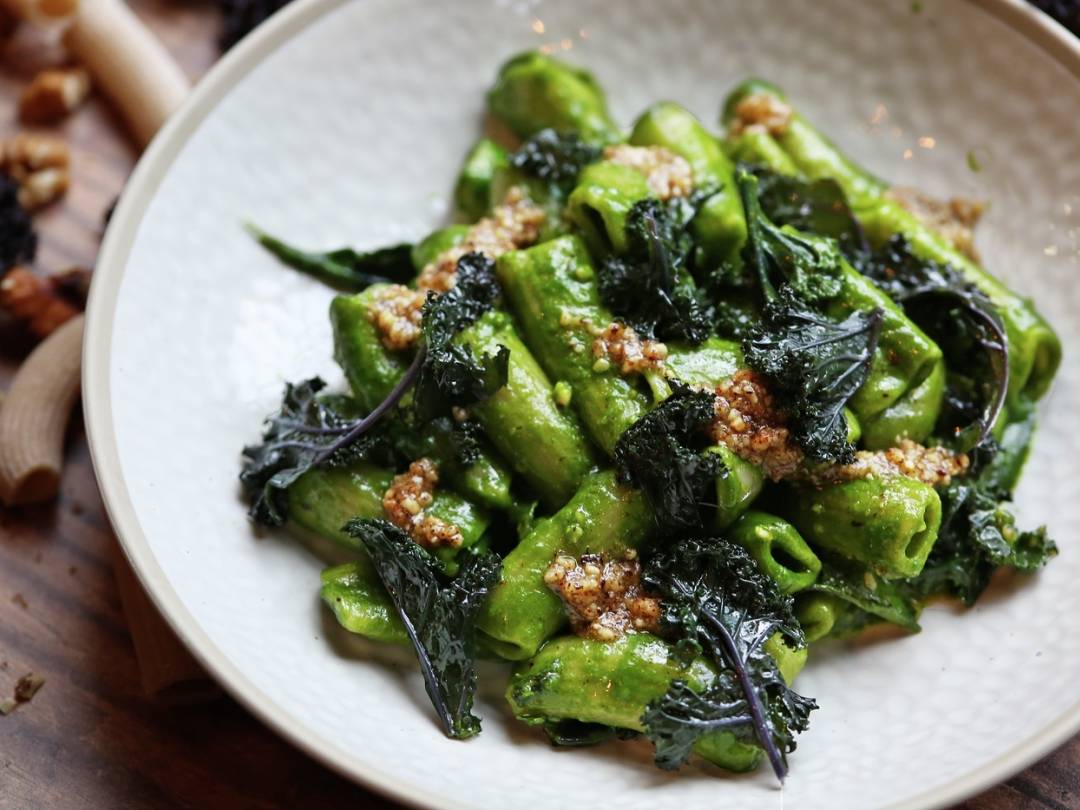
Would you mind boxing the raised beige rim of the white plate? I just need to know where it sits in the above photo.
[82,0,1080,810]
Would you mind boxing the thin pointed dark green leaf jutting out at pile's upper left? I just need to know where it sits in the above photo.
[246,224,416,292]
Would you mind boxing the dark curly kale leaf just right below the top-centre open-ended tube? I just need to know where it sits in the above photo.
[596,191,713,343]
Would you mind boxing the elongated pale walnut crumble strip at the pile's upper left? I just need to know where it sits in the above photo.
[416,187,544,293]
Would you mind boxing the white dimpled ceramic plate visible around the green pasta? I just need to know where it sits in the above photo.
[84,0,1080,810]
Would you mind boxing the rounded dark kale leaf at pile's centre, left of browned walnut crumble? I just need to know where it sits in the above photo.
[612,387,728,531]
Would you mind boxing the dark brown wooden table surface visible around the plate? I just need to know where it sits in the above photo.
[0,0,1080,810]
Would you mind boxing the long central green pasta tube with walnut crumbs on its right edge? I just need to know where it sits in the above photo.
[497,237,650,453]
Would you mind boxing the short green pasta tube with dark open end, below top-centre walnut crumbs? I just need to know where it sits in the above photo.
[566,161,649,256]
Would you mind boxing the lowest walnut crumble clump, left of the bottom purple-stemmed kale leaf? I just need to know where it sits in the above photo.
[543,550,660,642]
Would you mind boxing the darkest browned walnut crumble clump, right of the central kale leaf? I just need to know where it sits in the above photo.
[710,368,802,481]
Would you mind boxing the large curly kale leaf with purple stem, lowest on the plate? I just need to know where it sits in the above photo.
[642,538,816,781]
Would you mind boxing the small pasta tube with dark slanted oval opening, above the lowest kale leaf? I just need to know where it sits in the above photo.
[726,511,821,594]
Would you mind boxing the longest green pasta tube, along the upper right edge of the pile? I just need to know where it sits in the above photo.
[725,81,1062,408]
